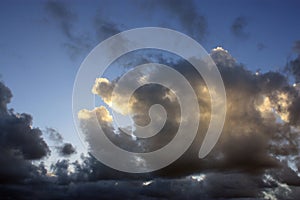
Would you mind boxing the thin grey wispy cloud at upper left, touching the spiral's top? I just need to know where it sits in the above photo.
[45,1,120,59]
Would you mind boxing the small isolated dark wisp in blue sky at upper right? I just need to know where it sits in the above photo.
[230,16,249,39]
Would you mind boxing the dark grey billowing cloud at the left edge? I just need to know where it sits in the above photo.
[0,82,50,183]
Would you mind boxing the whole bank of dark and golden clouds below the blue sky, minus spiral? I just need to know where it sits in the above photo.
[0,43,300,199]
